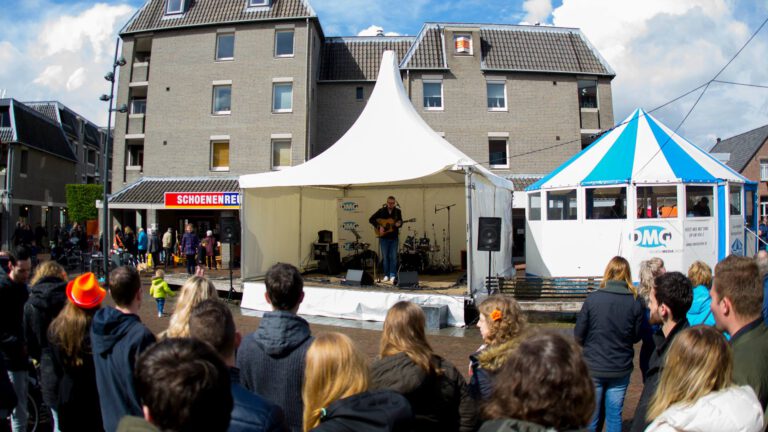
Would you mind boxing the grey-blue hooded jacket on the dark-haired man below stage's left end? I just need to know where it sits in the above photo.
[237,311,312,432]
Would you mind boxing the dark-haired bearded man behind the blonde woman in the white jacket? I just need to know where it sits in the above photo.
[632,272,693,432]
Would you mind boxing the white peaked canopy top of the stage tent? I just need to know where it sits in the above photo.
[240,51,513,190]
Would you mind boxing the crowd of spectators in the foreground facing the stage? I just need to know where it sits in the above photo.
[0,247,768,432]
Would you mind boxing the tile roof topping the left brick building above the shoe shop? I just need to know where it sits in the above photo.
[120,0,317,35]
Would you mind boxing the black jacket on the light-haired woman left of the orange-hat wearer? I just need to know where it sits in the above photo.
[24,277,67,361]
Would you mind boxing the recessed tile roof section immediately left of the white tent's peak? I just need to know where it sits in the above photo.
[320,36,416,81]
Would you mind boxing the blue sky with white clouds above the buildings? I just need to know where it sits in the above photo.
[0,0,768,149]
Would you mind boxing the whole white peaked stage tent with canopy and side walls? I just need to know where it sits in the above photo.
[240,51,514,289]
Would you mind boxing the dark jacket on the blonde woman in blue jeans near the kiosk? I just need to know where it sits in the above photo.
[573,281,643,378]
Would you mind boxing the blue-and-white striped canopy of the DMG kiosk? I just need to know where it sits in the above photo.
[526,108,749,191]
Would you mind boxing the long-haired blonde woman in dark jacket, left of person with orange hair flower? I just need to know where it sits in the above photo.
[371,301,477,432]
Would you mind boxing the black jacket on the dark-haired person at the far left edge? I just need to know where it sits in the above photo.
[0,275,29,371]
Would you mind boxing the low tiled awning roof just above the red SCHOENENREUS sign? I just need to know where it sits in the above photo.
[109,177,240,204]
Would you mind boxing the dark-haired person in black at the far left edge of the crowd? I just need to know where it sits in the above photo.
[0,246,32,432]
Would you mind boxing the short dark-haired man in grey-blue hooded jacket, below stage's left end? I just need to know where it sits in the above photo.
[237,263,312,432]
